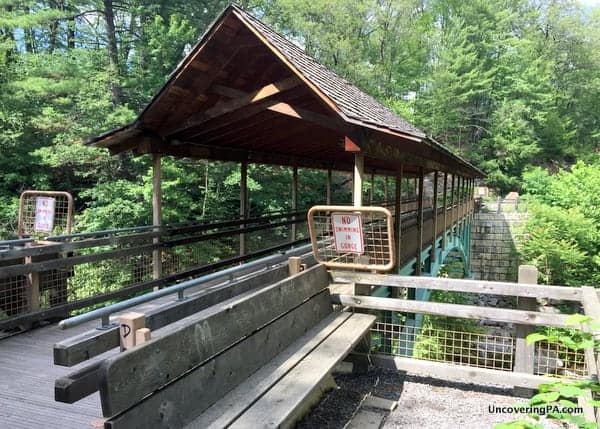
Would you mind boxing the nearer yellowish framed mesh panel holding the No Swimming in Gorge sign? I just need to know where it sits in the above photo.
[308,206,395,271]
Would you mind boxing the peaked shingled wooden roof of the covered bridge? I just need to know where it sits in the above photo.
[89,5,482,177]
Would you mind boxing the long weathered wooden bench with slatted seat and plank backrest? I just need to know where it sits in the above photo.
[98,265,375,429]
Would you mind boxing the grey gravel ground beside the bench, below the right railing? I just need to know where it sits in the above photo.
[298,368,560,429]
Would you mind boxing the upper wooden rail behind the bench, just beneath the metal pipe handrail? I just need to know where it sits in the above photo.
[54,267,288,366]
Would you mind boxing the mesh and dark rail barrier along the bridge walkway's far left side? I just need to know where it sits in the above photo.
[0,213,308,329]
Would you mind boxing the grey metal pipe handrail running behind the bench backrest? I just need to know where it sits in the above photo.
[58,244,311,329]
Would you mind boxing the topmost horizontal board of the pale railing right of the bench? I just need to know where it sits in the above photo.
[330,270,584,300]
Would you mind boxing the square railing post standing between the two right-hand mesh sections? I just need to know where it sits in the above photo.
[513,265,538,397]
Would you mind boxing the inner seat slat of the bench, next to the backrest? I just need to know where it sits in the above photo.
[186,313,352,429]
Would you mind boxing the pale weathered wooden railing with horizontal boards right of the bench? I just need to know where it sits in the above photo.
[330,266,600,423]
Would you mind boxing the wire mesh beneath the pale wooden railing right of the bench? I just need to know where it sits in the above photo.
[371,312,587,378]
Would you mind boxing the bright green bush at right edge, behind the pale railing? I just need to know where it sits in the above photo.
[518,162,600,286]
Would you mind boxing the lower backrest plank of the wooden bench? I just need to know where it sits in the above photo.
[103,291,331,429]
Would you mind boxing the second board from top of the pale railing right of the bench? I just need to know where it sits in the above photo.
[331,295,568,327]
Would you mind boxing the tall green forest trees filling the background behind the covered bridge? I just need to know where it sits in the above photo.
[0,0,600,239]
